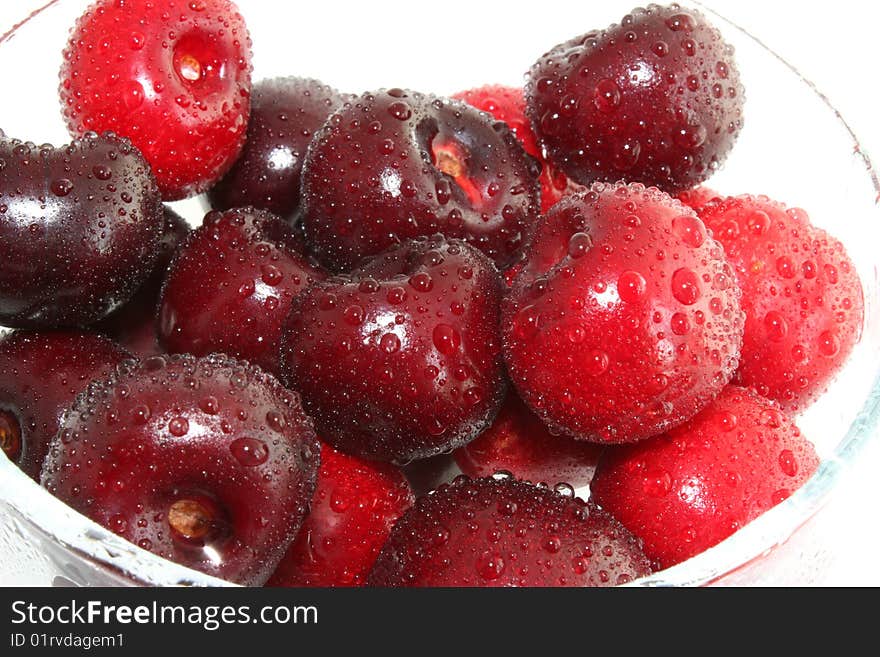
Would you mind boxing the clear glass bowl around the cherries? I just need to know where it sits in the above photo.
[0,0,880,586]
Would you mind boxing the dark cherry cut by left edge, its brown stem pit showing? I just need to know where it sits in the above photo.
[0,331,131,480]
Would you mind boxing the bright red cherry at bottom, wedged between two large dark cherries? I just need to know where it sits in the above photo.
[267,445,414,586]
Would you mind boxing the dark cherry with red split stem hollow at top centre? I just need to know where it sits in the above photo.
[302,89,540,271]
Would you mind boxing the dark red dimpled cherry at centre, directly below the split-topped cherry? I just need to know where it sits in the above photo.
[281,236,506,462]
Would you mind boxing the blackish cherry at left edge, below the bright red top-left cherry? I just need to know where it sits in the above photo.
[0,133,162,329]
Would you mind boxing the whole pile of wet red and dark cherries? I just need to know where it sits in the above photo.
[0,0,864,586]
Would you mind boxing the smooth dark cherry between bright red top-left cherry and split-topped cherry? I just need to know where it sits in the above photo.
[208,77,343,223]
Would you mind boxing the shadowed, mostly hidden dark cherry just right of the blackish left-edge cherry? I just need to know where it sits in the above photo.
[94,206,189,358]
